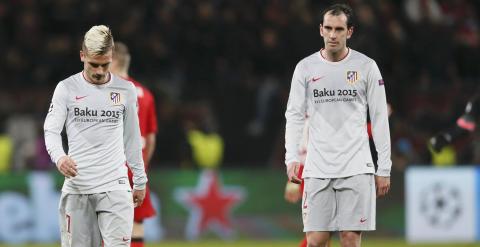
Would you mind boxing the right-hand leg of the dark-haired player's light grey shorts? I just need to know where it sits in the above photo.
[334,174,376,231]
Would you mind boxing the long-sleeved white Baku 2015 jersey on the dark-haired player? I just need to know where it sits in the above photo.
[285,49,392,178]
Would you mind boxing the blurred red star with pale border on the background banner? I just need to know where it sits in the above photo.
[175,171,245,239]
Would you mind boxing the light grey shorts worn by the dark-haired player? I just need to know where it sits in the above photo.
[302,174,376,232]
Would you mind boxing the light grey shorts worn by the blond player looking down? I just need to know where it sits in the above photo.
[59,190,133,247]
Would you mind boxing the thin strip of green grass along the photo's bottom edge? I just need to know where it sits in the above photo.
[0,239,480,247]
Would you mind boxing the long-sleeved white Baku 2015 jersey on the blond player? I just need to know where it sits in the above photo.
[44,72,147,194]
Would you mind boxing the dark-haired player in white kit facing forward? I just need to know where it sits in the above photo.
[285,4,392,247]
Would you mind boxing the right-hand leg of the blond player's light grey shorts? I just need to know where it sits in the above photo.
[96,190,133,247]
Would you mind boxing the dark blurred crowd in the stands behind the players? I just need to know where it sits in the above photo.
[0,0,480,171]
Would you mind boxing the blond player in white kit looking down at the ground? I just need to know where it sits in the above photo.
[44,25,147,247]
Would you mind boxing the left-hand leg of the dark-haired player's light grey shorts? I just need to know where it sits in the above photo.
[302,178,336,232]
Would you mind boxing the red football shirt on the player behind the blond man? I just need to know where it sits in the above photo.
[128,77,157,161]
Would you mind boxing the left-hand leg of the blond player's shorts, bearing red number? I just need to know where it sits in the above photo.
[59,193,101,247]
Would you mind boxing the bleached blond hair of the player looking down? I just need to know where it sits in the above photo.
[82,25,114,56]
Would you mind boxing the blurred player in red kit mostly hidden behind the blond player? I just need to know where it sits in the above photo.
[111,42,157,247]
